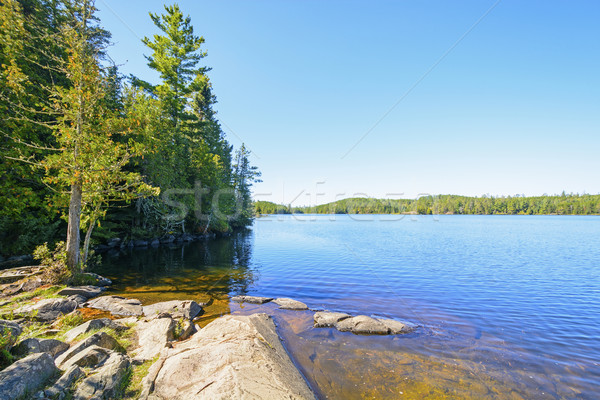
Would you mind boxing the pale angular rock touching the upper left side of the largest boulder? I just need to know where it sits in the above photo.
[135,318,177,360]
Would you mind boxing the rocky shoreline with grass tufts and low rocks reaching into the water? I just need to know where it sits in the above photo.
[0,269,417,400]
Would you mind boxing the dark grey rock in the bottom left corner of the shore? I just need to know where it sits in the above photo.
[0,353,56,400]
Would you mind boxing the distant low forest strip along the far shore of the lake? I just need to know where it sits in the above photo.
[254,193,600,215]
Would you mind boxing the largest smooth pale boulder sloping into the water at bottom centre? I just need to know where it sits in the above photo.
[141,314,315,400]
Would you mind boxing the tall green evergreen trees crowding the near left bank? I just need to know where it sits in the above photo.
[0,0,260,268]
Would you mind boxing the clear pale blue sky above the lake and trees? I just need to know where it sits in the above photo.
[96,0,600,205]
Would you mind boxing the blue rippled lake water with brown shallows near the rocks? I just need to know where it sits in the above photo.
[99,215,600,399]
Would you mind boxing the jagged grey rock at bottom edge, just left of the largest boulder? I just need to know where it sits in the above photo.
[73,352,130,400]
